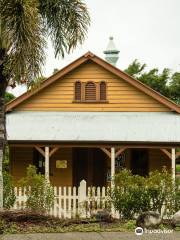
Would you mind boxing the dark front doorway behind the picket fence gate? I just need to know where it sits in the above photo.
[73,148,107,187]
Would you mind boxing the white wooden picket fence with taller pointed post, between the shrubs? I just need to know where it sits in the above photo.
[14,180,111,218]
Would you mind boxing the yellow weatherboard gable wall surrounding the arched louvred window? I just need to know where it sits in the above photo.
[15,61,170,112]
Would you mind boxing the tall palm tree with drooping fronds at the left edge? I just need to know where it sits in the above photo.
[0,0,90,208]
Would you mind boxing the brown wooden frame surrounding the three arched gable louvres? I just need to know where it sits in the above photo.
[73,81,109,103]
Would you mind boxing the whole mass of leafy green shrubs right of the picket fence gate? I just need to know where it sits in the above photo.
[110,168,180,219]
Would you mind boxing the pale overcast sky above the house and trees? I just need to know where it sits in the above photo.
[10,0,180,96]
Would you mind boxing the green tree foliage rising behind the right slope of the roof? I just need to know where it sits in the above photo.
[125,59,180,104]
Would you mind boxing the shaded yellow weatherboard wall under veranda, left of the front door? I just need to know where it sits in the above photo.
[10,147,72,186]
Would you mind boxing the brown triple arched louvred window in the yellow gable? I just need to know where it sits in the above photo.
[74,81,107,103]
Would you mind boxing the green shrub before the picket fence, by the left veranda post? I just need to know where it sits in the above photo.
[19,165,54,213]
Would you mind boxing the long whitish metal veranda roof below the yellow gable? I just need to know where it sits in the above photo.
[6,112,180,143]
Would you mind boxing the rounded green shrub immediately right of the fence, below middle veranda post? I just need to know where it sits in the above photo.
[111,169,150,219]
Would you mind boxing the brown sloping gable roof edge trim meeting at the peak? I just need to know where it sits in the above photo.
[6,52,180,113]
